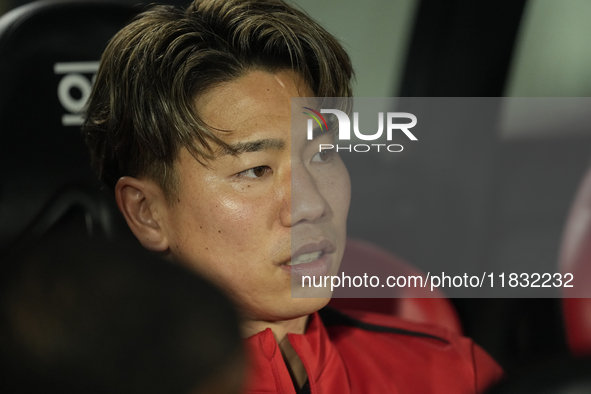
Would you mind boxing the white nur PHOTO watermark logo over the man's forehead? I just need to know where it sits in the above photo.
[302,107,418,152]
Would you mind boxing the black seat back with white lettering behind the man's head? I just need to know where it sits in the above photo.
[0,0,138,250]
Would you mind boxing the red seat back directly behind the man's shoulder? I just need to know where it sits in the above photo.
[328,238,462,334]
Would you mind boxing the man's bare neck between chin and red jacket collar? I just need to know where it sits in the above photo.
[242,316,309,390]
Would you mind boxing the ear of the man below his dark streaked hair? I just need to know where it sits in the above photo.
[115,176,169,252]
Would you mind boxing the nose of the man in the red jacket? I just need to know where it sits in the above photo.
[287,163,328,226]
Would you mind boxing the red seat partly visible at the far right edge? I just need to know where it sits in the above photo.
[559,169,591,356]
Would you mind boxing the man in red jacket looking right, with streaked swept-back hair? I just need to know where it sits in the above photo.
[84,0,500,393]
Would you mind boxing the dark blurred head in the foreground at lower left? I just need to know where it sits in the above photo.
[0,231,245,394]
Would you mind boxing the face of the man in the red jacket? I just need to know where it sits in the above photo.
[163,71,351,321]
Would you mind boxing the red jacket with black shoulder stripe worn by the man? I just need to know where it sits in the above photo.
[246,308,503,394]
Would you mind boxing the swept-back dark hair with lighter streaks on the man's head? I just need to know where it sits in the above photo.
[83,0,353,197]
